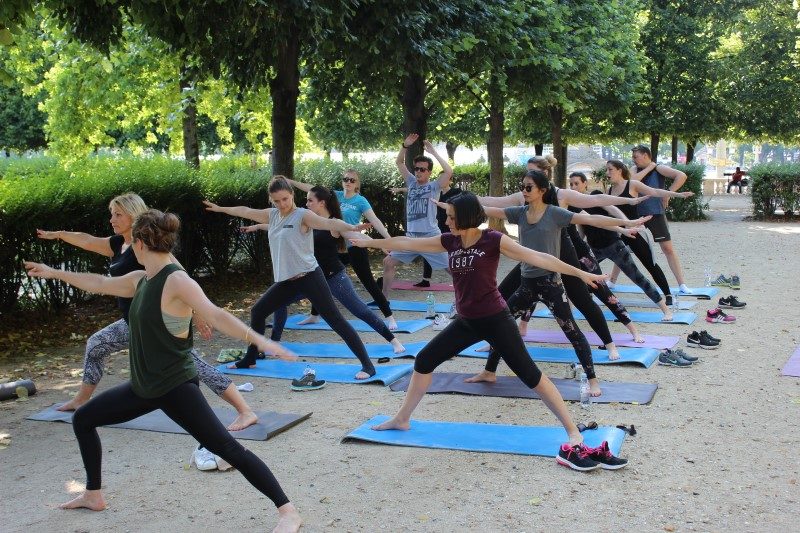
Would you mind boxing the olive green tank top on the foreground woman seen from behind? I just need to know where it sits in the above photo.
[128,264,197,398]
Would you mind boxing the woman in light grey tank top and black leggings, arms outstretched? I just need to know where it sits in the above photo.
[203,176,375,379]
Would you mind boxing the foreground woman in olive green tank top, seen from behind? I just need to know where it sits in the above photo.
[25,209,302,532]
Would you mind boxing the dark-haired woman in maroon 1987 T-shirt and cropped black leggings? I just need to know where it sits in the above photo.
[353,192,624,470]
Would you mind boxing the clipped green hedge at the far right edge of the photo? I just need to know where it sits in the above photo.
[749,163,800,218]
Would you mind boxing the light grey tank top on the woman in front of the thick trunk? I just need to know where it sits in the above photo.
[268,207,317,283]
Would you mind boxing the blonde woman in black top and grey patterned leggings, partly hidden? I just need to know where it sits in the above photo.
[36,193,258,431]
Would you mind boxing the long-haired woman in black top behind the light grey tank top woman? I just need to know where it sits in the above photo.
[250,186,405,353]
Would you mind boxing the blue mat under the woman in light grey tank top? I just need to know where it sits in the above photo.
[217,359,414,385]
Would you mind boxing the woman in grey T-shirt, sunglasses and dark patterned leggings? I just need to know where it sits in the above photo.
[468,170,647,396]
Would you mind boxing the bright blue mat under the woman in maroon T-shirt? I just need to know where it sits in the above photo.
[342,415,625,457]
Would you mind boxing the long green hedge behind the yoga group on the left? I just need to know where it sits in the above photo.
[0,156,536,310]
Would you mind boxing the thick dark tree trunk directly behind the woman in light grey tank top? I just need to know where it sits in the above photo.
[269,32,300,178]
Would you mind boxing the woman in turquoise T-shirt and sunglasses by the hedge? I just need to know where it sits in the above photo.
[287,168,397,330]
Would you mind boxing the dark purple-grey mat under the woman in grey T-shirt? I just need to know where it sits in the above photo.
[390,372,658,404]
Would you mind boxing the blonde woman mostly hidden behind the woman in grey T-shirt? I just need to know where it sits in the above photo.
[481,155,642,360]
